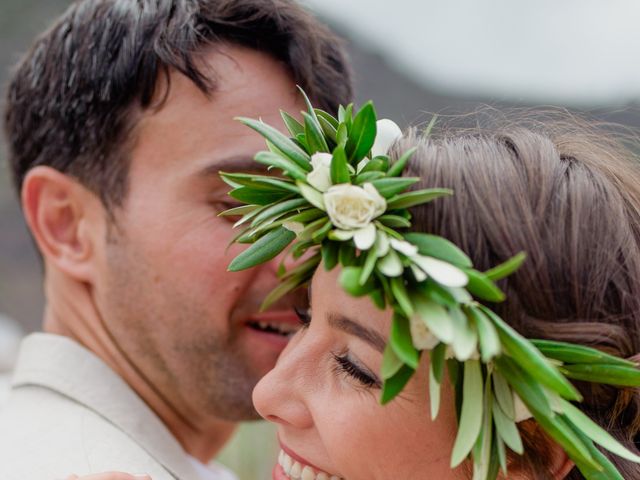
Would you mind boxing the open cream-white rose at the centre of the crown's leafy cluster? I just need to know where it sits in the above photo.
[323,183,387,231]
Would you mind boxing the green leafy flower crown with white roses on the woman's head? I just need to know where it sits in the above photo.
[221,92,640,480]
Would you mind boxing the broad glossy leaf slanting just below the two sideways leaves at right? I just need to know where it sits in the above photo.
[479,305,582,401]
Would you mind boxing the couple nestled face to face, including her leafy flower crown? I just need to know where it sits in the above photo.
[0,0,640,480]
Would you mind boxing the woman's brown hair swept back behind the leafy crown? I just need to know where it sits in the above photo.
[395,113,640,479]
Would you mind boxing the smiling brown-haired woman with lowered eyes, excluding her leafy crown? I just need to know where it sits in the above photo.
[70,113,640,480]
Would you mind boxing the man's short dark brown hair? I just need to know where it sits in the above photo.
[5,0,352,211]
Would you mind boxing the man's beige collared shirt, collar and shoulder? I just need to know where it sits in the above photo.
[0,333,238,480]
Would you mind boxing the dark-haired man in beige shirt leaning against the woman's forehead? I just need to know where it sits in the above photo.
[0,0,351,480]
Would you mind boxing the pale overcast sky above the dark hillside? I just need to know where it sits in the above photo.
[303,0,640,105]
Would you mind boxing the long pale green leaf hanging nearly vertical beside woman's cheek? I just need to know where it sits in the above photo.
[451,360,483,468]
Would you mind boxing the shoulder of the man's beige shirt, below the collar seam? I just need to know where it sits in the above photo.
[0,386,172,480]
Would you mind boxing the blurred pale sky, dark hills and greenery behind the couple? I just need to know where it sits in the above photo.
[0,0,640,480]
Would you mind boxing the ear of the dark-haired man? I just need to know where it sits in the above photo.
[21,166,102,281]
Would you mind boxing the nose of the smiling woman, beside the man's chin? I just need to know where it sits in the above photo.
[253,340,313,429]
